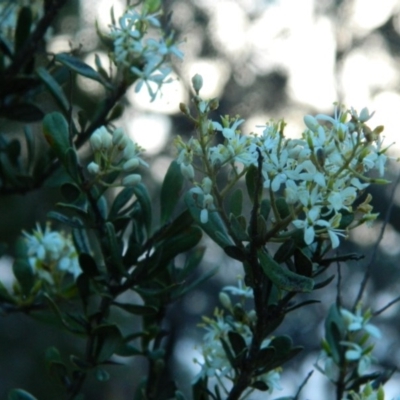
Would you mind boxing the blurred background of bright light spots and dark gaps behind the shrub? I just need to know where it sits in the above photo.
[0,0,400,400]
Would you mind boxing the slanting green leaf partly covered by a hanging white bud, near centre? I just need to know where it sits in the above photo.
[185,191,233,248]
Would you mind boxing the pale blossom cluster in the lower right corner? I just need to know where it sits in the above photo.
[316,307,381,382]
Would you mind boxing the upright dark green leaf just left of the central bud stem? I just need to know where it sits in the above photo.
[160,160,184,224]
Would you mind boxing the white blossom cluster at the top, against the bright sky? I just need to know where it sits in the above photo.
[111,8,183,100]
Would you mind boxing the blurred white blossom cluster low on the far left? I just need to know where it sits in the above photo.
[23,224,82,284]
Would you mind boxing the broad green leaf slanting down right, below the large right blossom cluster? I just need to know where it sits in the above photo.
[258,250,314,292]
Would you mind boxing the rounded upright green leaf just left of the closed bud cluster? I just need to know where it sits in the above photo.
[43,112,71,163]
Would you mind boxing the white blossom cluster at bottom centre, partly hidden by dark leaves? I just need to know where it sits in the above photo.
[194,279,282,397]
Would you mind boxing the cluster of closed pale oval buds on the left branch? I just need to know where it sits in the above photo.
[87,126,148,186]
